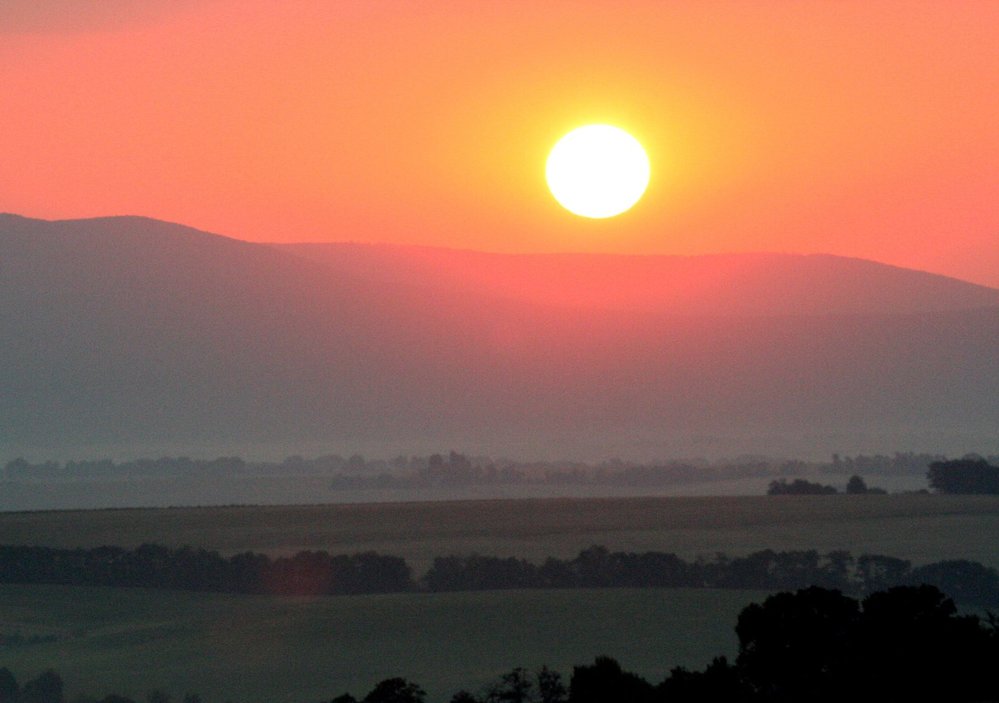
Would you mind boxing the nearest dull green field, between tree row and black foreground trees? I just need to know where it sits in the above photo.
[0,586,764,703]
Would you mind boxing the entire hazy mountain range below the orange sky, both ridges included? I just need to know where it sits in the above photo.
[0,216,999,459]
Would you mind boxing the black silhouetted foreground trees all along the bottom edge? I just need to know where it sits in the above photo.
[0,585,999,703]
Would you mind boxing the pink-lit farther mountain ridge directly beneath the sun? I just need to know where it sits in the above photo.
[275,243,999,315]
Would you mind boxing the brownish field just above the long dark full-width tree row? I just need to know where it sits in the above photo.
[0,495,999,574]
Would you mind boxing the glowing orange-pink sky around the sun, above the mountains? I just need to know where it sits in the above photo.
[0,0,999,286]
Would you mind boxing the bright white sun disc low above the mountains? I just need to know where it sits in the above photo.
[545,124,649,218]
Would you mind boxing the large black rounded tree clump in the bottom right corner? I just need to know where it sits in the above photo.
[736,585,999,703]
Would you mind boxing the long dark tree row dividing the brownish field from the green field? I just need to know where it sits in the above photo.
[0,544,999,606]
